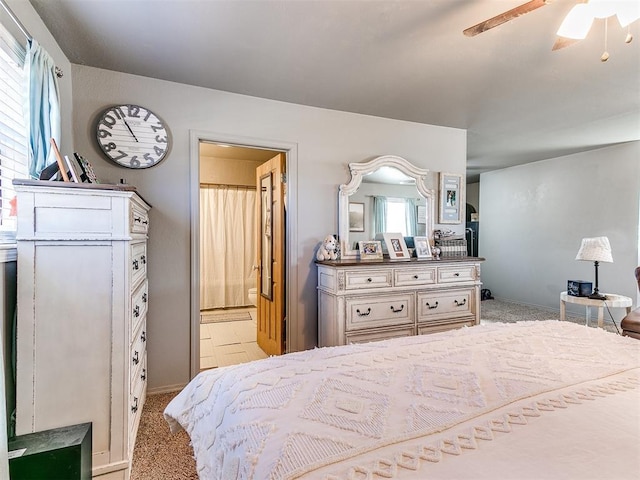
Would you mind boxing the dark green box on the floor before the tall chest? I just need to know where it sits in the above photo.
[9,423,92,480]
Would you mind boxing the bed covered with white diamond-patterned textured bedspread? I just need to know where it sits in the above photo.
[164,321,640,480]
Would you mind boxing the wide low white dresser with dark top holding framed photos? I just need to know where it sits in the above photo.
[317,257,484,347]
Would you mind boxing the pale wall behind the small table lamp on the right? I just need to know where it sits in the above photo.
[479,142,640,320]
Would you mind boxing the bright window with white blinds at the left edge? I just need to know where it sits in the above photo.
[0,20,29,241]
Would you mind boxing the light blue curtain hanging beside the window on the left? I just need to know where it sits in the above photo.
[24,39,60,178]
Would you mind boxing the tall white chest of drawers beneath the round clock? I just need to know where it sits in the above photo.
[15,180,150,480]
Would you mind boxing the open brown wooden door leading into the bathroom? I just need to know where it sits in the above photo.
[256,153,286,355]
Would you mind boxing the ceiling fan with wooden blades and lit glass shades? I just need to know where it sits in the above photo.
[463,0,640,61]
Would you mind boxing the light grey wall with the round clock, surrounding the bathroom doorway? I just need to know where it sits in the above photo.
[70,65,466,389]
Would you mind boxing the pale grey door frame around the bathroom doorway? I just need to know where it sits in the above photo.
[189,130,302,379]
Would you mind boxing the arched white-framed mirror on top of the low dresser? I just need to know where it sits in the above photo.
[338,155,435,259]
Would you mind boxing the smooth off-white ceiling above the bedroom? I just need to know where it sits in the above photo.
[30,0,640,181]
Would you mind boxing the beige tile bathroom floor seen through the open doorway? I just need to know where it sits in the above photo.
[200,308,267,370]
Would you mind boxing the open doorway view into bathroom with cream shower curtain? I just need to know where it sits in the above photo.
[199,142,280,370]
